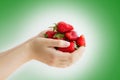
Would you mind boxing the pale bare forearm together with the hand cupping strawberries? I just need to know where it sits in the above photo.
[0,31,85,80]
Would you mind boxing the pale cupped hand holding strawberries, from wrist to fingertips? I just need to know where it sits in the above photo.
[29,31,84,68]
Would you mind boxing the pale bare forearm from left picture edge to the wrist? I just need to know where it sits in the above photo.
[0,42,31,80]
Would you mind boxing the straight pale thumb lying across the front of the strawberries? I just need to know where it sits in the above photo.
[39,38,70,47]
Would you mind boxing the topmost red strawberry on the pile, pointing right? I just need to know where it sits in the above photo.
[57,22,73,33]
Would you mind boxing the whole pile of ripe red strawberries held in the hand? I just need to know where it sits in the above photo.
[45,21,86,53]
